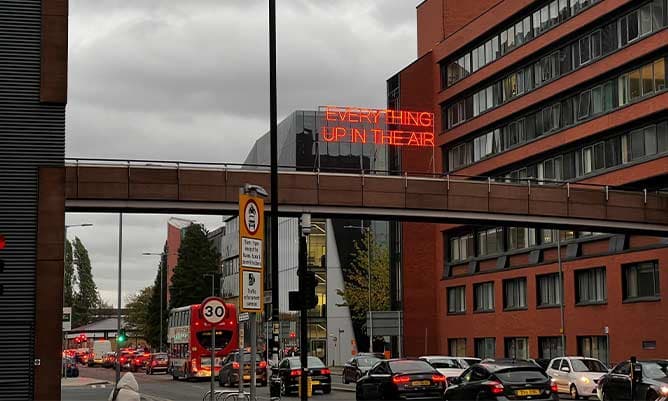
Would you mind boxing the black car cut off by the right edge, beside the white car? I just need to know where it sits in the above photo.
[597,359,668,401]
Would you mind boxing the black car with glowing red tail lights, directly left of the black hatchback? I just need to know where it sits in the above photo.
[355,359,445,401]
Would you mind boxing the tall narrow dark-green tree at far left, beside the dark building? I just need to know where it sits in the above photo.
[72,237,100,327]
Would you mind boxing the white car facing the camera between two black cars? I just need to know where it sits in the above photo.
[546,356,608,400]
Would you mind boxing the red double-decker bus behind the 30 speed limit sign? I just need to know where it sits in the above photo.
[167,304,239,379]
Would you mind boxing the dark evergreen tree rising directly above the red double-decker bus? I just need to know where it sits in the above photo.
[169,224,220,309]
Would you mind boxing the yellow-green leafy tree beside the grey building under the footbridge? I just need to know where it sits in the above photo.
[336,230,390,324]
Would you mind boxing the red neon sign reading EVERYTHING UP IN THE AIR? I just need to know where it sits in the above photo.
[320,106,434,148]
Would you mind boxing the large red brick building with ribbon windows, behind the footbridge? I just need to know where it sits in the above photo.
[388,0,668,362]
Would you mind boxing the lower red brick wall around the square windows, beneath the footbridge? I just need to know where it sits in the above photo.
[437,248,668,361]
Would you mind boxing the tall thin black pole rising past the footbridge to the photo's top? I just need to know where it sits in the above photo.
[269,0,279,365]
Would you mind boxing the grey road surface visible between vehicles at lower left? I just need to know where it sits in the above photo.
[61,367,355,401]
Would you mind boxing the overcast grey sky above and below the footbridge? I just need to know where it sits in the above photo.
[66,0,420,305]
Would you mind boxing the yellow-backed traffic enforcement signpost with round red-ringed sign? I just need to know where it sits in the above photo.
[239,184,266,398]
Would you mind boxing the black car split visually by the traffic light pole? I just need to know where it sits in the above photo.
[271,356,332,395]
